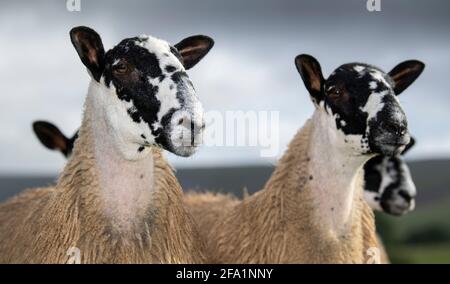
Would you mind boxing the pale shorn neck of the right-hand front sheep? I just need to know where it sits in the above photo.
[309,109,370,236]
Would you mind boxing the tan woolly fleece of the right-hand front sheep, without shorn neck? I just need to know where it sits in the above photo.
[185,121,378,263]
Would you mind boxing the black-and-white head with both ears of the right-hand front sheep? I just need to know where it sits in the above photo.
[295,55,424,156]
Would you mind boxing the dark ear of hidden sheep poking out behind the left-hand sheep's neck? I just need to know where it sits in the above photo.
[33,121,70,156]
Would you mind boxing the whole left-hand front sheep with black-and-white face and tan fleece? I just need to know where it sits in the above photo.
[0,27,213,263]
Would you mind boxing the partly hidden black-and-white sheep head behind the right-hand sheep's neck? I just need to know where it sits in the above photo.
[364,138,416,216]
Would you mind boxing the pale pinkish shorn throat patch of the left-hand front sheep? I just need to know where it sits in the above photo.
[88,84,155,231]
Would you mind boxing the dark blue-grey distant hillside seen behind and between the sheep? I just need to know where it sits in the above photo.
[0,160,450,206]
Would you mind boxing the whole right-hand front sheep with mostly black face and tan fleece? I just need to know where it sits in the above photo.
[185,55,424,263]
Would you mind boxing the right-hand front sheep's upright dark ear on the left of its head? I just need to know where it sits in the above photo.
[295,54,325,100]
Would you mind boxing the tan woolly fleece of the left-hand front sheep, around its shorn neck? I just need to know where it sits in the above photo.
[0,98,204,263]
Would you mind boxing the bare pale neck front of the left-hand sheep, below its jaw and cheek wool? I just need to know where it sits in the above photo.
[69,82,156,233]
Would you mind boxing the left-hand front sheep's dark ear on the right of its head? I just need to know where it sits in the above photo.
[175,35,214,69]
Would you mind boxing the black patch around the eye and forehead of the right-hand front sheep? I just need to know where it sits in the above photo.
[318,63,391,139]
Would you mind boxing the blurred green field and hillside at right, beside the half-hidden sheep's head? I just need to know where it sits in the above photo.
[376,160,450,263]
